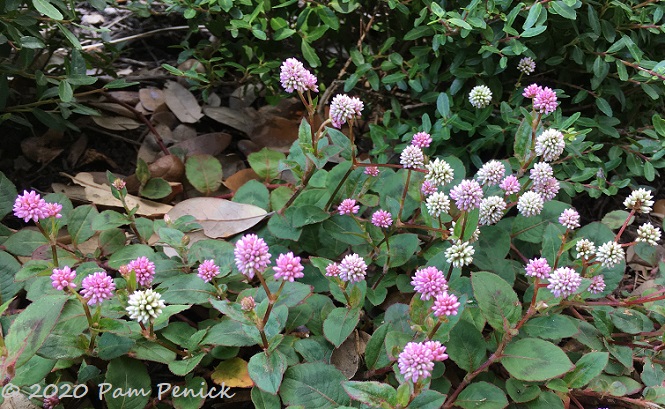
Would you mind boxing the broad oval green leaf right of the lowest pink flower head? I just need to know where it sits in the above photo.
[501,338,574,381]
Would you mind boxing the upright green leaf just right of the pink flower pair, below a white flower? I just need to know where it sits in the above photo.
[471,271,522,331]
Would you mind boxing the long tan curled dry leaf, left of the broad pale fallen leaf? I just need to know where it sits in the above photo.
[53,172,172,217]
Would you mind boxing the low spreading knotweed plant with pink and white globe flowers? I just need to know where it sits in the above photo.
[0,53,665,409]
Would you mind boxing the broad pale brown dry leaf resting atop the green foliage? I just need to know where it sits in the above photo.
[167,197,268,239]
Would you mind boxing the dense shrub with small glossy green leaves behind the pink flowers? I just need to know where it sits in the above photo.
[162,0,665,196]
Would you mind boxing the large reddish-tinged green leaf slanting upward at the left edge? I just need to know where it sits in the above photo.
[4,295,68,367]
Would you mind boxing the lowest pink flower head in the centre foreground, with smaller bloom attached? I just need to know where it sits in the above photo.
[397,341,448,382]
